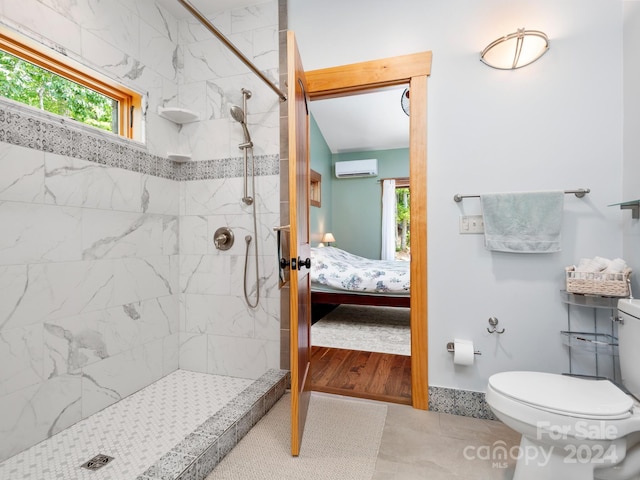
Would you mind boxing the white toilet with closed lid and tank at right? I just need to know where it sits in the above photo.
[486,299,640,480]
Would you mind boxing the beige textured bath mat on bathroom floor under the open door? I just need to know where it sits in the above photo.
[207,392,387,480]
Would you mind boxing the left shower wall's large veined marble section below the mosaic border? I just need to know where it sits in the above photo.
[0,143,179,459]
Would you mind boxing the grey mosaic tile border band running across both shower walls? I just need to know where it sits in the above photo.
[0,100,280,181]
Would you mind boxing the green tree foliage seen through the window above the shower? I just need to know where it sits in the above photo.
[0,50,119,133]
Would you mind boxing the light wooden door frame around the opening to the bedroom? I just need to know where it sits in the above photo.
[305,51,432,410]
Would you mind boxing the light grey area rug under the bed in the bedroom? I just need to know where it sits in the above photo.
[311,305,411,355]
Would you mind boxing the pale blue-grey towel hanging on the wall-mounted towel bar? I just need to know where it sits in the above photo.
[480,190,564,253]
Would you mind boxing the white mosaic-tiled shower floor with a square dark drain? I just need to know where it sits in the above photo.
[0,370,253,480]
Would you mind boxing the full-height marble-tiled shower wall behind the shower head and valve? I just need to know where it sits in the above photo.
[178,0,280,378]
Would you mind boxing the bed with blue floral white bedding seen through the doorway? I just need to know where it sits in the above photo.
[310,247,411,307]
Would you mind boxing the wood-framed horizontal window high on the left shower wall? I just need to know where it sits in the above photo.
[0,31,141,138]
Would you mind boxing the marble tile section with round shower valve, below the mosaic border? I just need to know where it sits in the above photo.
[180,175,280,378]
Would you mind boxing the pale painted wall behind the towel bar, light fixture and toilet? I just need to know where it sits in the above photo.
[289,0,624,390]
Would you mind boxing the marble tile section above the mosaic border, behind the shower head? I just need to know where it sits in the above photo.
[178,0,280,160]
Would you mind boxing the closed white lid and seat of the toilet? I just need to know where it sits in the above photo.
[489,372,633,419]
